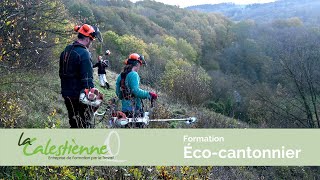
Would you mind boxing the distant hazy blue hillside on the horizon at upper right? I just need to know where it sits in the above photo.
[186,0,320,25]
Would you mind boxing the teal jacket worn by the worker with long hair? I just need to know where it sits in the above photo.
[116,71,151,112]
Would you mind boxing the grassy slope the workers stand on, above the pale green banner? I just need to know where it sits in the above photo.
[2,69,247,128]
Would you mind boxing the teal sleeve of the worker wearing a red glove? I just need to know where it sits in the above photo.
[127,72,151,99]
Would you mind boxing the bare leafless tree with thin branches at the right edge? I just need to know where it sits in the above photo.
[264,28,320,128]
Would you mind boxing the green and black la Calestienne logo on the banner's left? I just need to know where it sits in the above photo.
[18,131,125,162]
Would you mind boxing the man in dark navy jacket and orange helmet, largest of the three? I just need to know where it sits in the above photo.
[59,24,101,128]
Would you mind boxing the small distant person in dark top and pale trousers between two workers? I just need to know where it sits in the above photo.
[93,50,110,89]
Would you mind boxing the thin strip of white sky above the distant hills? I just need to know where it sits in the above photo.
[131,0,275,8]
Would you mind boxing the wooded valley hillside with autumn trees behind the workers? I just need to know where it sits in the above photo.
[60,1,320,128]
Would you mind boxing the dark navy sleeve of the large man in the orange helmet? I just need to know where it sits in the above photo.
[80,53,94,89]
